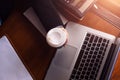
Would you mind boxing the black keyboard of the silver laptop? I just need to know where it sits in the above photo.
[70,33,109,80]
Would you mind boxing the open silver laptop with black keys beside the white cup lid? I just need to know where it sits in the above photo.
[44,22,120,80]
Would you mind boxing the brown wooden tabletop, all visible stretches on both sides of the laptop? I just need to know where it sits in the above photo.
[0,0,120,80]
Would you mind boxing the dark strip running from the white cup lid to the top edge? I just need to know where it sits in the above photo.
[33,0,63,31]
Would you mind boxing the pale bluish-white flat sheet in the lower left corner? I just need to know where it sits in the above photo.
[0,36,33,80]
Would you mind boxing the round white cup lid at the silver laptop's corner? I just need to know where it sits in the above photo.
[46,26,68,48]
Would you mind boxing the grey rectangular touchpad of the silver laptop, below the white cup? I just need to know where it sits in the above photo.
[54,45,77,69]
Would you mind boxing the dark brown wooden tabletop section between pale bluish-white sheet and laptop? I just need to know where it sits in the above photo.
[0,12,55,80]
